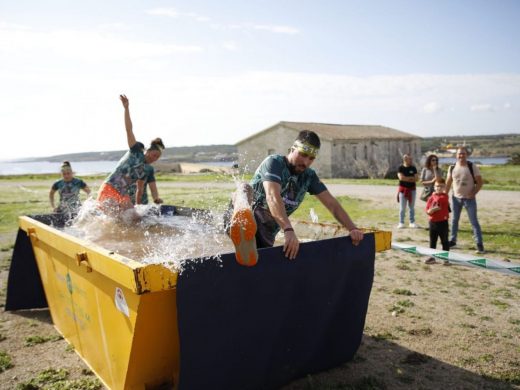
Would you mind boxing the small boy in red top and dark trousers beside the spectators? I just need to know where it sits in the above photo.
[425,177,450,265]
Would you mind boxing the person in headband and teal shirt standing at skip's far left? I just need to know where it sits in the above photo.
[49,161,90,217]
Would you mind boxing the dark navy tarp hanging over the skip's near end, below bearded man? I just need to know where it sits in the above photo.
[177,234,375,390]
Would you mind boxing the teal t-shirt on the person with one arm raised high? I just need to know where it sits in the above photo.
[105,142,146,195]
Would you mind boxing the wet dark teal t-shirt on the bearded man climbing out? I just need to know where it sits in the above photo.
[250,154,327,235]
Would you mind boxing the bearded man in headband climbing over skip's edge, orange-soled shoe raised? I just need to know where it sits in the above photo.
[226,130,363,265]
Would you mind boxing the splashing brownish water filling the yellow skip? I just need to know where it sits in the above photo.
[64,200,233,272]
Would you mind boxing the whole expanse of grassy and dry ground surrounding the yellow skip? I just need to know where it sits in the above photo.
[0,172,520,390]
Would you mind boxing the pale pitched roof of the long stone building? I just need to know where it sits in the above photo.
[236,121,420,145]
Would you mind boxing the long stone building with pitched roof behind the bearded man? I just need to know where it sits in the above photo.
[236,122,421,178]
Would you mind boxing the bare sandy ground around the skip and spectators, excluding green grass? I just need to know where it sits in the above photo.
[0,183,520,390]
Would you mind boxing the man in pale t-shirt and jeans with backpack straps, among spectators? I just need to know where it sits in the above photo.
[446,147,485,254]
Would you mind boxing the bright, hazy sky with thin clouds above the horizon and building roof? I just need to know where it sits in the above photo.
[0,0,520,160]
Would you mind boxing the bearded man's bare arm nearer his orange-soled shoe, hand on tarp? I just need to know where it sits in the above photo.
[263,181,300,260]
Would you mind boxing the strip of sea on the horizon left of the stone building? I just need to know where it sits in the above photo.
[0,160,233,176]
